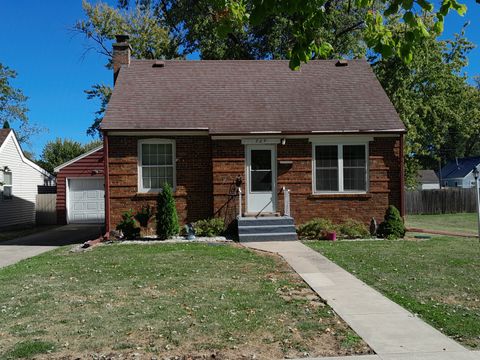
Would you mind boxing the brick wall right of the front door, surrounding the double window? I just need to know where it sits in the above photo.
[277,137,401,224]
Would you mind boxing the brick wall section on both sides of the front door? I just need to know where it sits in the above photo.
[212,137,401,224]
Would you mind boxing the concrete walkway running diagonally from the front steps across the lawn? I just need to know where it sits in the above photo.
[243,241,480,360]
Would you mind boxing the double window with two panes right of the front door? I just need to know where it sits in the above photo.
[313,144,368,193]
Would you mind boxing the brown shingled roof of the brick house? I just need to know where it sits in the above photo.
[102,60,405,134]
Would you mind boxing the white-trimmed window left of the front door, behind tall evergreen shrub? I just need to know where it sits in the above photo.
[138,139,175,192]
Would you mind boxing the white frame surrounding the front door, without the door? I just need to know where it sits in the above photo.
[245,143,277,215]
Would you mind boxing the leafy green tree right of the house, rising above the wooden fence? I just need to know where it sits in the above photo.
[372,21,480,187]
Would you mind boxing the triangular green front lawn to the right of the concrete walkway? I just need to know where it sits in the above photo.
[307,237,480,349]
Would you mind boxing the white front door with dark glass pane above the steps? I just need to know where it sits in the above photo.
[246,145,277,214]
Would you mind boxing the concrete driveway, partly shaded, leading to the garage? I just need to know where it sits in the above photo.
[0,224,102,268]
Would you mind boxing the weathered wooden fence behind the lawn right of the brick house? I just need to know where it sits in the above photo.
[406,188,477,215]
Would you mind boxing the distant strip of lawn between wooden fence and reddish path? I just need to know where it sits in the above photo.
[406,213,477,235]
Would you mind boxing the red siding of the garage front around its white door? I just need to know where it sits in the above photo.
[57,149,104,224]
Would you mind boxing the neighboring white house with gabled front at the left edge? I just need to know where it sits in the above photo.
[0,129,52,228]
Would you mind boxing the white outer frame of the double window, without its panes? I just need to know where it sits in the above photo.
[312,140,370,195]
